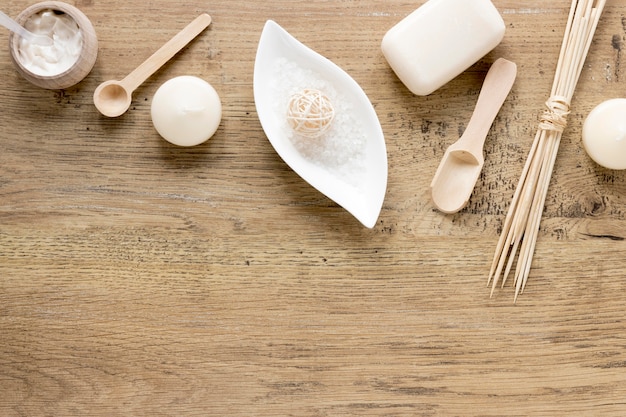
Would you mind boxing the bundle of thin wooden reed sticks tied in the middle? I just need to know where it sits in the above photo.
[487,0,606,302]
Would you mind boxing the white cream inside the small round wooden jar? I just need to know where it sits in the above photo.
[19,10,83,76]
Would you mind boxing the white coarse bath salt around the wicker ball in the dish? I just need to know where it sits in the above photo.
[270,58,367,186]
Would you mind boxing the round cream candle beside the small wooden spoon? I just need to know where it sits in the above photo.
[151,75,222,146]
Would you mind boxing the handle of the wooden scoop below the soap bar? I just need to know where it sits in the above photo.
[459,58,517,155]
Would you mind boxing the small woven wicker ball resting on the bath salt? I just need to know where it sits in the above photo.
[287,88,335,138]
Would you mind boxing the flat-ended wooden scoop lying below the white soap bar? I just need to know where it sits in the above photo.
[430,58,517,213]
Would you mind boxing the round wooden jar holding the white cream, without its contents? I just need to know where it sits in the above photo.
[9,1,98,90]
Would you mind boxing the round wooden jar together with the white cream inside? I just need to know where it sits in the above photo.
[9,1,98,89]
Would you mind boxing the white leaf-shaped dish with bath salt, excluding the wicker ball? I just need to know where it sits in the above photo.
[254,20,387,228]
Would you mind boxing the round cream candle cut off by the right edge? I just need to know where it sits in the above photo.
[583,98,626,169]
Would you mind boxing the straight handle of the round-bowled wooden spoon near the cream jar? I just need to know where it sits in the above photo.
[121,13,211,93]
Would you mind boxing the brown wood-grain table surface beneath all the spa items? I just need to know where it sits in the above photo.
[0,0,626,417]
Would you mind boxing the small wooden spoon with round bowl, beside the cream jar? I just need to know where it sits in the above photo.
[93,13,211,117]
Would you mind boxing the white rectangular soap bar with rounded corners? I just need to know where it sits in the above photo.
[382,0,505,96]
